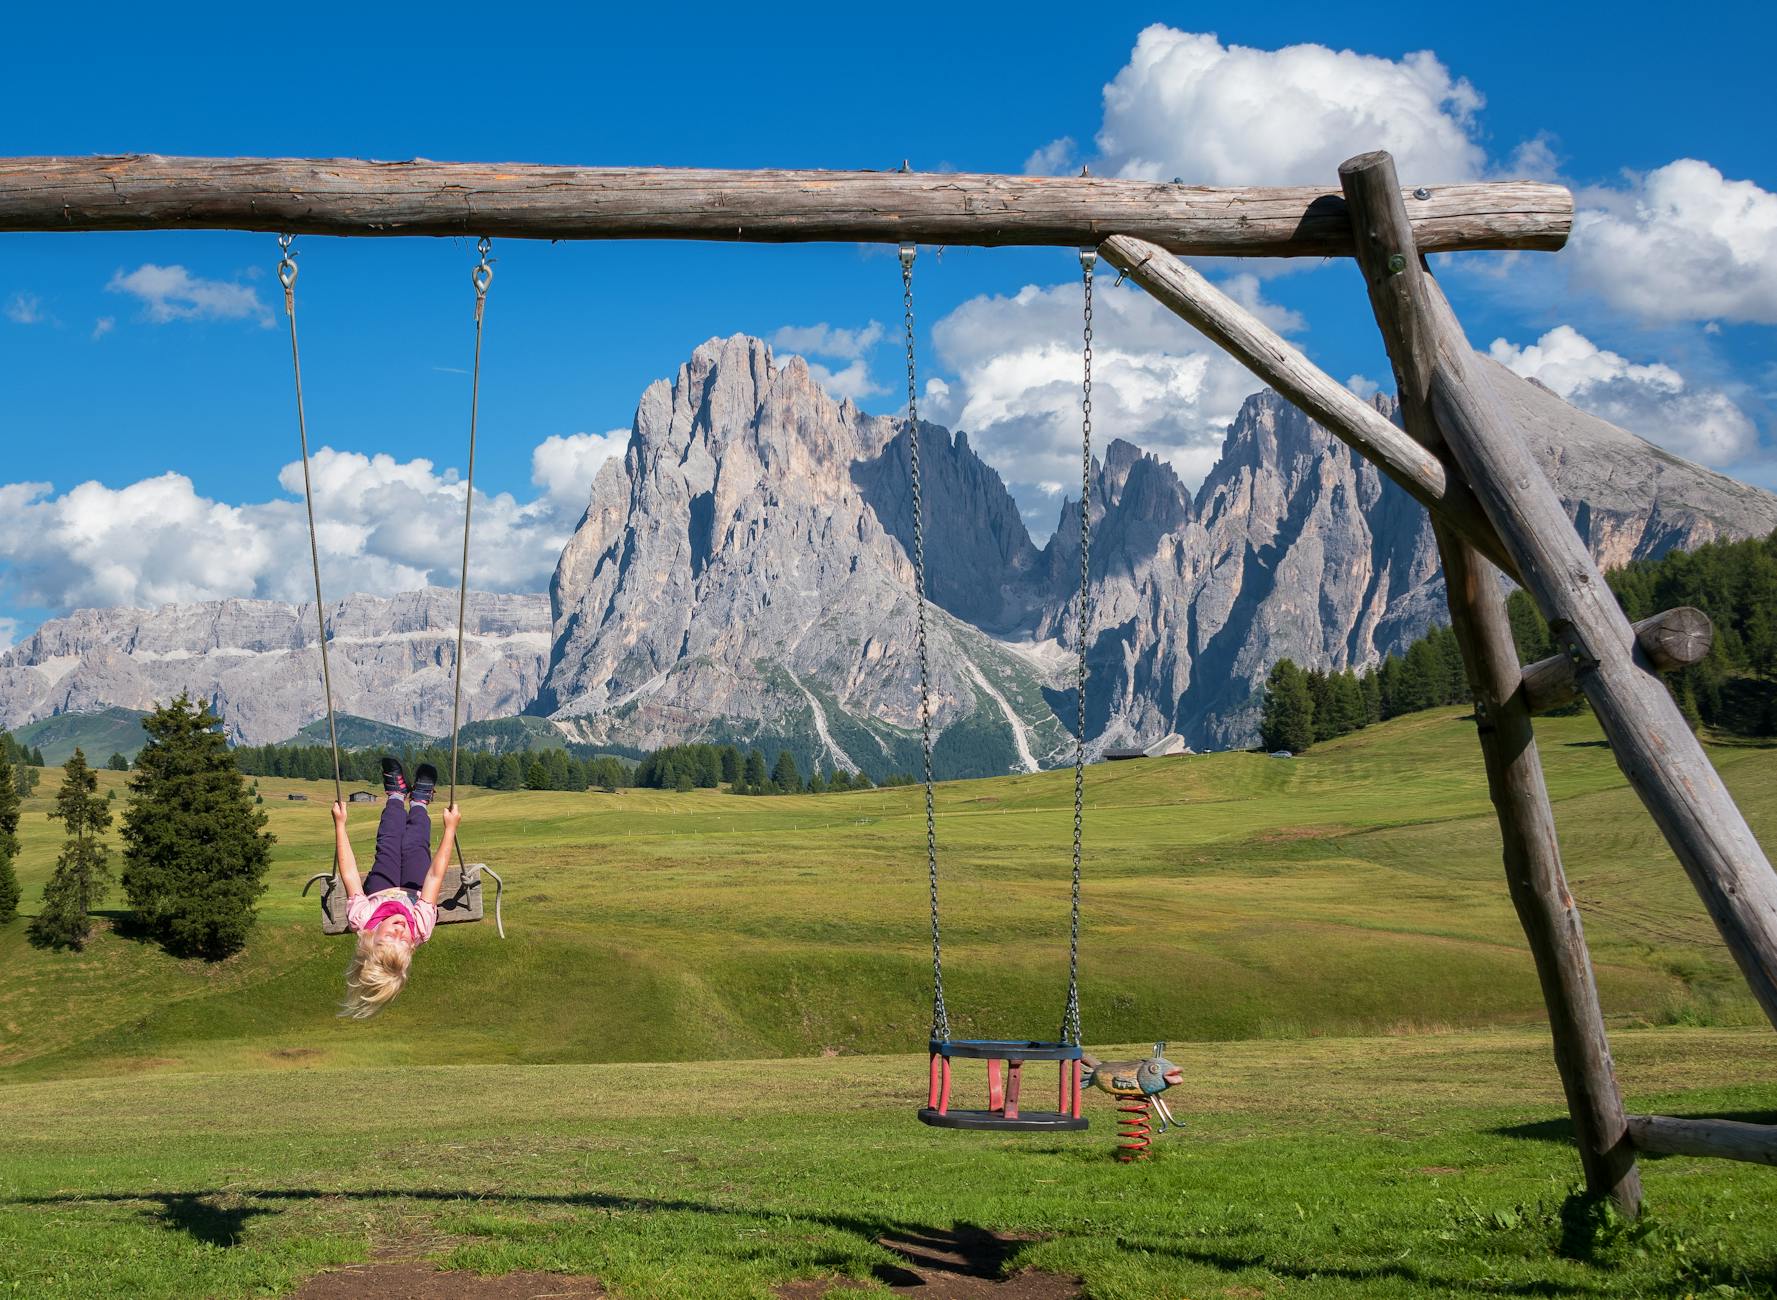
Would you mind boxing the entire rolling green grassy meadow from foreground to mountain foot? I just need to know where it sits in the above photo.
[0,709,1777,1296]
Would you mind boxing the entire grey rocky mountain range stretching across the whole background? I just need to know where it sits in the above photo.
[0,336,1777,776]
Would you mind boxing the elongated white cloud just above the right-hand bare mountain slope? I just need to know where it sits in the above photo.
[1489,325,1757,465]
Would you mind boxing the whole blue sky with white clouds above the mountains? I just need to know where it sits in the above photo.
[0,4,1777,645]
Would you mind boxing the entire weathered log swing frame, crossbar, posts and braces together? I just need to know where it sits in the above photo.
[0,153,1777,1213]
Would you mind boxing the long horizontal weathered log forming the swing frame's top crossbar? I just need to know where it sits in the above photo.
[0,155,1573,258]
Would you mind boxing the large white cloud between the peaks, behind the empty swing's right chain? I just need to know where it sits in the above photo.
[920,284,1260,524]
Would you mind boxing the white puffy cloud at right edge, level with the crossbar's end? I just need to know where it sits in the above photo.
[1569,158,1777,325]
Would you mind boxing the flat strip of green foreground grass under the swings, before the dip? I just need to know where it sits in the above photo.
[0,1028,1777,1300]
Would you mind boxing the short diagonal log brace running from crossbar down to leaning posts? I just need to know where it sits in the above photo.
[1098,234,1512,568]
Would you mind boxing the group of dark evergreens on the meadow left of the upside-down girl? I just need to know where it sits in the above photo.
[0,694,274,961]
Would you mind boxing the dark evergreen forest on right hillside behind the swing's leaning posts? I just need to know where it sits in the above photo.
[1258,529,1777,753]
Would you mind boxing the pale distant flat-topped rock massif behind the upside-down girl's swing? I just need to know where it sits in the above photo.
[0,590,549,744]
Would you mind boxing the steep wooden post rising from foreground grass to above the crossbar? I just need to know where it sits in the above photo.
[1340,155,1642,1215]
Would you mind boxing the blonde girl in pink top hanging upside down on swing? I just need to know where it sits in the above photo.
[334,758,462,1019]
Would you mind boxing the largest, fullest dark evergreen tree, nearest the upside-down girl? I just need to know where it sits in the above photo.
[123,694,274,961]
